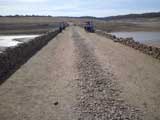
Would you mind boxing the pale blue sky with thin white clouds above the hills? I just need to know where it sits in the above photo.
[0,0,160,17]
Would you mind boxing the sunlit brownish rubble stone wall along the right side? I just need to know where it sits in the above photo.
[96,30,160,60]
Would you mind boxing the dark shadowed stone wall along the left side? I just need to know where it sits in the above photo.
[0,29,60,82]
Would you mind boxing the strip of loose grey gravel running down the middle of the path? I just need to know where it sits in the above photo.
[72,29,142,120]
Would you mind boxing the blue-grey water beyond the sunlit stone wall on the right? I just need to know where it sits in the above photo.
[111,32,160,43]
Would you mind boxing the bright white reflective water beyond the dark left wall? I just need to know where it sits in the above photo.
[0,35,39,47]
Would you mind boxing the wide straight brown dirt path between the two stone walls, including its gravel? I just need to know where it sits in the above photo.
[0,27,160,120]
